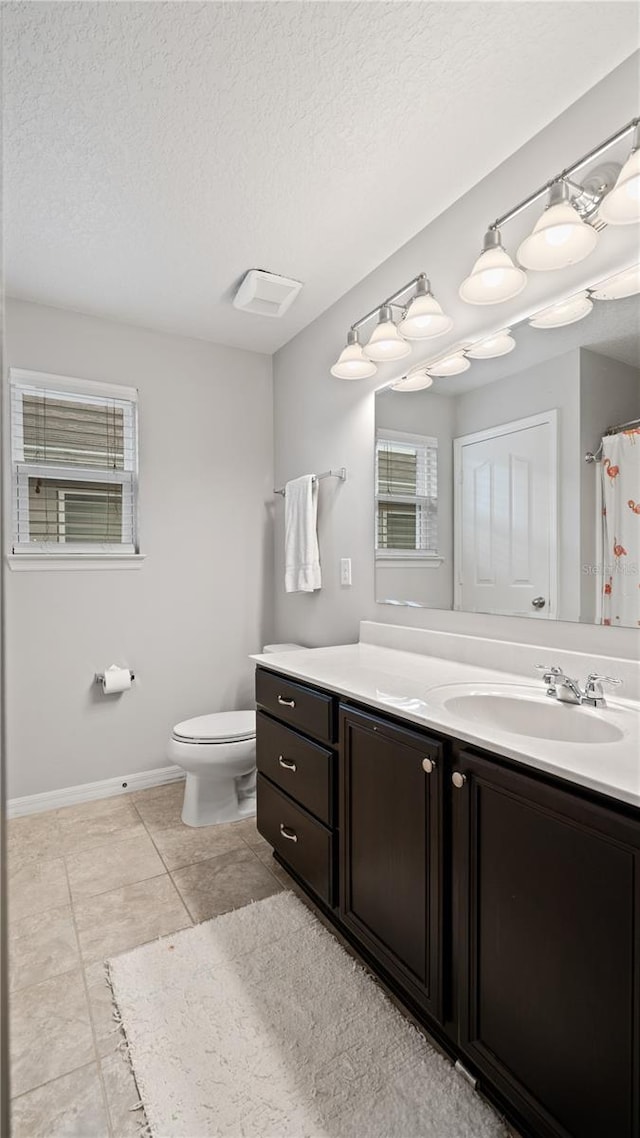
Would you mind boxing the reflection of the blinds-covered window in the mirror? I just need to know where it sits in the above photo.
[376,429,437,558]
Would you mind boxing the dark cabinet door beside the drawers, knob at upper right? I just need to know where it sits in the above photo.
[340,710,442,1019]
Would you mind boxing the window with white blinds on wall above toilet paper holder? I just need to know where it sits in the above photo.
[9,370,138,556]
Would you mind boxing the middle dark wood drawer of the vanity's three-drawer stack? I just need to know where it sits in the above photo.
[256,711,334,826]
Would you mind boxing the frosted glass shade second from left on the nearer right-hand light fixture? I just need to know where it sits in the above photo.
[518,182,598,272]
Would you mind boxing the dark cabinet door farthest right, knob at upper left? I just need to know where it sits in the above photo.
[452,746,640,1138]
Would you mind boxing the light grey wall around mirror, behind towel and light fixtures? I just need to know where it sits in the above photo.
[268,56,638,655]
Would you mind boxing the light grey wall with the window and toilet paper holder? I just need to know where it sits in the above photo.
[5,300,273,798]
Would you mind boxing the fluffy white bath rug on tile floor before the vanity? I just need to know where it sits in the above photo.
[109,893,507,1138]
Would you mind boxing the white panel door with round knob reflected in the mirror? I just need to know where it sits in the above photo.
[453,411,557,618]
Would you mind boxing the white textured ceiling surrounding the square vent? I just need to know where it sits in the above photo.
[3,0,639,352]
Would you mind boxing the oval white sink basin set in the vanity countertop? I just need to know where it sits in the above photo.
[427,684,631,744]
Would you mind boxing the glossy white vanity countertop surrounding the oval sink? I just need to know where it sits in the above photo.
[252,643,640,807]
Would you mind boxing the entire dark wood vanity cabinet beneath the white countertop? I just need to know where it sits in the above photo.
[257,673,640,1138]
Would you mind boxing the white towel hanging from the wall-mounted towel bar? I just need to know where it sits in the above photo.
[285,475,322,593]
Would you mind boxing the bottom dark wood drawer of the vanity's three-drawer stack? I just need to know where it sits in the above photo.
[257,774,334,905]
